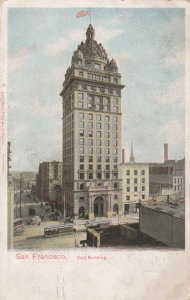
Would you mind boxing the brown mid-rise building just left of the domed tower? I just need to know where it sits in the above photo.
[37,161,62,207]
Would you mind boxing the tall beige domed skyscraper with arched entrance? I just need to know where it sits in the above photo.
[60,24,124,218]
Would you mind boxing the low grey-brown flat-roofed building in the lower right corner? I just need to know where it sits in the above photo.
[139,196,185,248]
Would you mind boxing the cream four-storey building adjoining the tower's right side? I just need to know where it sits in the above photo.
[120,163,149,214]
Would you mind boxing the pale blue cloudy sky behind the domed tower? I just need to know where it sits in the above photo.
[8,8,185,171]
